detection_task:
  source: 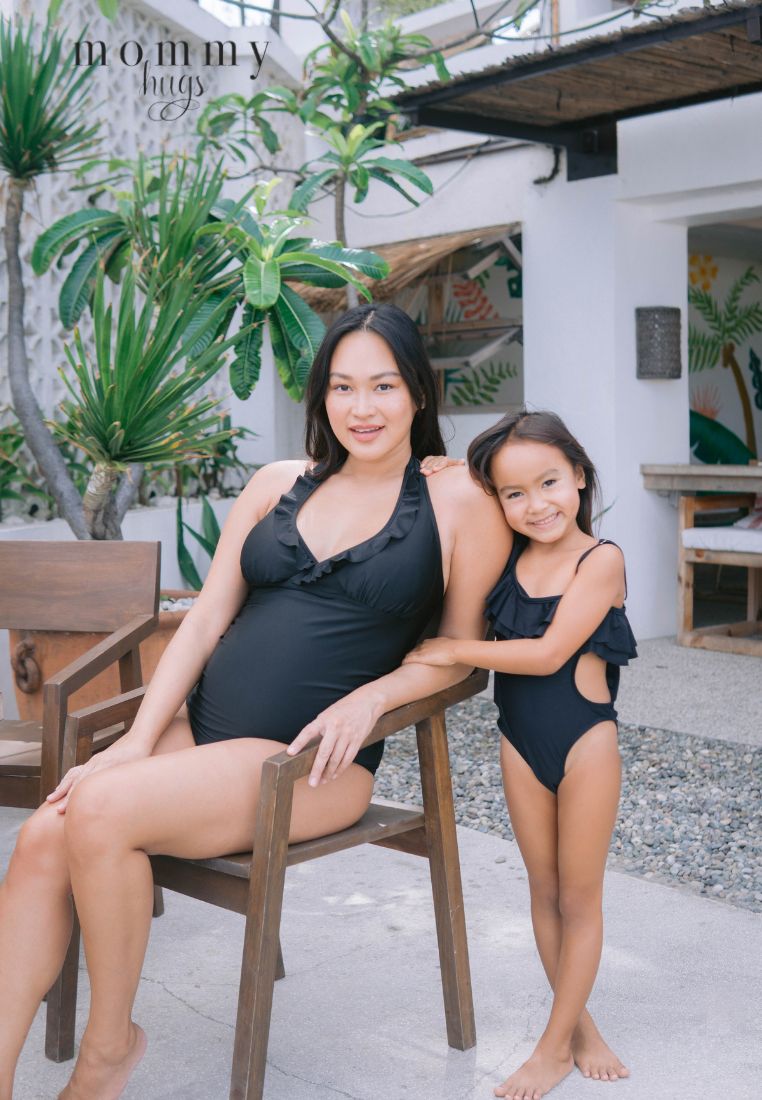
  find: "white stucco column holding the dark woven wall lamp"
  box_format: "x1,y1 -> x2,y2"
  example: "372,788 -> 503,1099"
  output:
523,176 -> 689,638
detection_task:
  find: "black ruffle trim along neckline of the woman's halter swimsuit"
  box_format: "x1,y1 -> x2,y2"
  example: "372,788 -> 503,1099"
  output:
274,458 -> 421,584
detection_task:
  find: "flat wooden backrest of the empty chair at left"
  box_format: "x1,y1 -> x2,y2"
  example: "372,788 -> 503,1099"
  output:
0,539 -> 162,631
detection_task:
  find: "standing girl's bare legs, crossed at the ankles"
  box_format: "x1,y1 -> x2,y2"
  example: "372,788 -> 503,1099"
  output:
495,725 -> 628,1100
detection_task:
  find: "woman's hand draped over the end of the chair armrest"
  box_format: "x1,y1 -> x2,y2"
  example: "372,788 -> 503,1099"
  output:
286,693 -> 383,787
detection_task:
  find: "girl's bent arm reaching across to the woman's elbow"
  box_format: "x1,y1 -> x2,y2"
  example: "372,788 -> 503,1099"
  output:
404,545 -> 625,677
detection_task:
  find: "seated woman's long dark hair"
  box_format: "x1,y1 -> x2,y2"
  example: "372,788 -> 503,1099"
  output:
305,303 -> 445,480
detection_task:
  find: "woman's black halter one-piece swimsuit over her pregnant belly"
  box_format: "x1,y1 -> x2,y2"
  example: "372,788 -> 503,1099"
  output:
188,459 -> 444,773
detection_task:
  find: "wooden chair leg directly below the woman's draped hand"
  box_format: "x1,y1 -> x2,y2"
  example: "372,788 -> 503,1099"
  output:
230,761 -> 294,1100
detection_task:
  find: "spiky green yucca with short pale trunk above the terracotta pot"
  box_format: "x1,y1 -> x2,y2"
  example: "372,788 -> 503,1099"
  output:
54,265 -> 247,539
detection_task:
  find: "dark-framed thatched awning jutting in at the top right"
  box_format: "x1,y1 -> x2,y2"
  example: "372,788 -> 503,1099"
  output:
395,0 -> 762,171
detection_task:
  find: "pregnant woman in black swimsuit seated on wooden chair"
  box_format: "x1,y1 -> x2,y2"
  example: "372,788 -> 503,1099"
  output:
0,306 -> 510,1100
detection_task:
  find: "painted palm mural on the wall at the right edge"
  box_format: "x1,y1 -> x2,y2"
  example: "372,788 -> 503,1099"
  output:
688,254 -> 762,464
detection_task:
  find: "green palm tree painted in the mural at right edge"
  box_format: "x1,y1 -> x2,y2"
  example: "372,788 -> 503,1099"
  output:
688,267 -> 762,455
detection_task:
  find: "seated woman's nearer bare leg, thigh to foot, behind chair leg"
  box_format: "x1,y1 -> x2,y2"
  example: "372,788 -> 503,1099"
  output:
62,721 -> 373,1100
